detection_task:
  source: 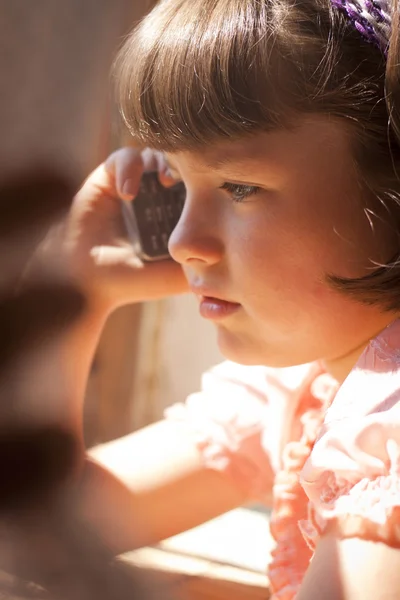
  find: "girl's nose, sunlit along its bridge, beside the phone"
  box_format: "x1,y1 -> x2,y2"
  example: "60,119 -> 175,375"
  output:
168,195 -> 224,266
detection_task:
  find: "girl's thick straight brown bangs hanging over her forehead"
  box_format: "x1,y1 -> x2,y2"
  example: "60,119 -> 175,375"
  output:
115,0 -> 298,151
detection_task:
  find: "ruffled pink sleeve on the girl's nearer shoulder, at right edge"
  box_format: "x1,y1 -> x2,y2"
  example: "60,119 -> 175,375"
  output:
300,321 -> 400,547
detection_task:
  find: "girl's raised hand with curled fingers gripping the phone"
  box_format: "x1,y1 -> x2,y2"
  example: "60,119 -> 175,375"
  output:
64,148 -> 187,310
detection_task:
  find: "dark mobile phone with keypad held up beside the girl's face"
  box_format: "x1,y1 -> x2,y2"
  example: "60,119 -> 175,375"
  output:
122,173 -> 186,261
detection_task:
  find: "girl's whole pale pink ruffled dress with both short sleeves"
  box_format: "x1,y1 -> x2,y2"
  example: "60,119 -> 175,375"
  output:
167,320 -> 400,600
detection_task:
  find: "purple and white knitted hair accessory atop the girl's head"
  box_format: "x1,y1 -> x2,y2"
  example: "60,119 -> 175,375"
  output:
331,0 -> 392,54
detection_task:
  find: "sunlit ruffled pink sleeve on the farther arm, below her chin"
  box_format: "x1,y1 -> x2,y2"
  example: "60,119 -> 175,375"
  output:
166,362 -> 318,501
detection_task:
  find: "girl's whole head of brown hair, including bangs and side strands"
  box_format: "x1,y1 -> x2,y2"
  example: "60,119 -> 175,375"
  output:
116,0 -> 400,310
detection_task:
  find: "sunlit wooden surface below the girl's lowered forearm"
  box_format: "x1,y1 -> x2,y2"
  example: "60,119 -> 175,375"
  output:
121,509 -> 272,600
